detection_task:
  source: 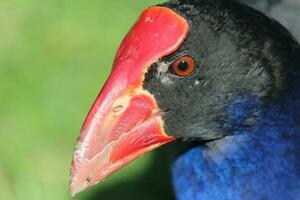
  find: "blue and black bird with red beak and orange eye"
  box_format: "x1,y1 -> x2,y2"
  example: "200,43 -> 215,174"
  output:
70,0 -> 300,200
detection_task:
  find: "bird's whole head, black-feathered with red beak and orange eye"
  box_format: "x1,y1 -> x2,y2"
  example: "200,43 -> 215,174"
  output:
70,0 -> 296,194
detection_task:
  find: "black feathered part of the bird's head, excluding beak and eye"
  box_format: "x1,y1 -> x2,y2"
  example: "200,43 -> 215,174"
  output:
144,0 -> 300,140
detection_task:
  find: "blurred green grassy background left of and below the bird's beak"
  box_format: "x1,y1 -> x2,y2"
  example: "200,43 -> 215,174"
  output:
0,0 -> 178,200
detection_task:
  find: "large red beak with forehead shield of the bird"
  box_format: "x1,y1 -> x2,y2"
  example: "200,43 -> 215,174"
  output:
70,7 -> 188,195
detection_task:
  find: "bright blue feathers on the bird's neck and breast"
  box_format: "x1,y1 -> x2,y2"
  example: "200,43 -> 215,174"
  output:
172,87 -> 300,200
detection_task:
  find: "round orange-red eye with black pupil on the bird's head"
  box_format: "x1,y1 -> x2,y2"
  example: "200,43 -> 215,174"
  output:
171,56 -> 196,76
